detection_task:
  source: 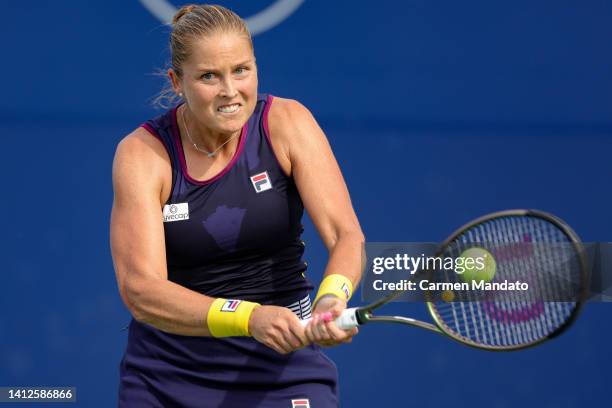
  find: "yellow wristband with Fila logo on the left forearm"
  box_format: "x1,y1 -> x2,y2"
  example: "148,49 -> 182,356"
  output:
206,298 -> 259,337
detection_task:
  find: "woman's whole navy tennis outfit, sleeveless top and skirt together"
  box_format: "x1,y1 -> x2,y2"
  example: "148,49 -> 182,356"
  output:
118,95 -> 338,408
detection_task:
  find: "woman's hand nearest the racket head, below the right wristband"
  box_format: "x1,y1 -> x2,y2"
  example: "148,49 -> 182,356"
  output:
304,296 -> 359,346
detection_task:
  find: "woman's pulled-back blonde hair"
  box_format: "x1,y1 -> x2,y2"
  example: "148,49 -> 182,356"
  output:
153,4 -> 253,108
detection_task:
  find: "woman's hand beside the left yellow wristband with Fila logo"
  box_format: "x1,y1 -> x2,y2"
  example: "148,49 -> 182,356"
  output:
249,306 -> 309,354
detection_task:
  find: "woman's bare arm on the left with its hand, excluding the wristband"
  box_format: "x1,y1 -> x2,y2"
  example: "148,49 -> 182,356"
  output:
110,128 -> 307,352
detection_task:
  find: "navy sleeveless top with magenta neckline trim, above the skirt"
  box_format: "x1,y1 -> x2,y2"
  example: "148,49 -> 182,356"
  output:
143,95 -> 313,305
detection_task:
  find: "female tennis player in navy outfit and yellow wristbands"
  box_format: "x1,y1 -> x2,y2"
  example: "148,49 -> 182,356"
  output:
111,5 -> 364,408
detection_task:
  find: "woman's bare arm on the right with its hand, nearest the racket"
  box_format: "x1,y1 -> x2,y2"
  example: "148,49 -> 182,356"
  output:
268,98 -> 364,345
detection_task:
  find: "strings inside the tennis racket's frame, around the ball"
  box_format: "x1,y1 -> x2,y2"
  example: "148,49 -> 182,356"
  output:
433,216 -> 580,347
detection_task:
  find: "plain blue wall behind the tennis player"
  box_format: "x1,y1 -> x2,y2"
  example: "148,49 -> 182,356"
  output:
0,0 -> 612,408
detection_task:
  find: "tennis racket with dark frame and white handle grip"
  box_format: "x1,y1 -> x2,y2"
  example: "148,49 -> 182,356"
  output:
304,210 -> 588,351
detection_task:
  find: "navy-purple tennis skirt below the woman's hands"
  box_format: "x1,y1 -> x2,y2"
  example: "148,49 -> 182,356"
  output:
119,312 -> 338,408
